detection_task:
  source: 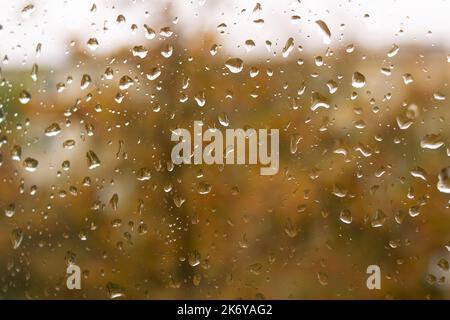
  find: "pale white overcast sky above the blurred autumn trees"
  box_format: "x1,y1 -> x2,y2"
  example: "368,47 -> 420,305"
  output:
0,0 -> 450,69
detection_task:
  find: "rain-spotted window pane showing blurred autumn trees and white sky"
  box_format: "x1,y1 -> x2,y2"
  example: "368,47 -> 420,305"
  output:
0,0 -> 450,299
